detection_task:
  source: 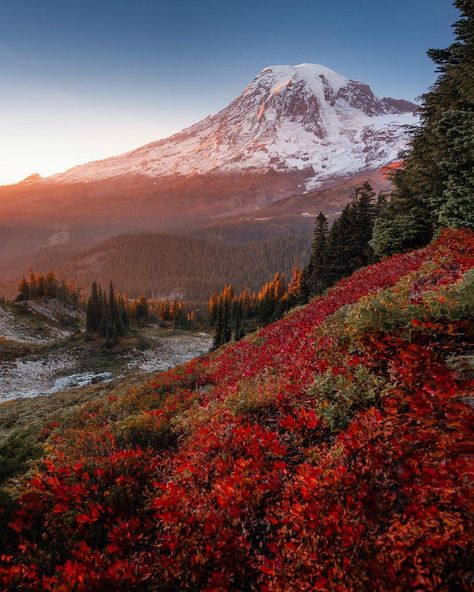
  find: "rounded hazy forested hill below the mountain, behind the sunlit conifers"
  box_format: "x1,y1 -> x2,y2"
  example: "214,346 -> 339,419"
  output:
62,234 -> 310,301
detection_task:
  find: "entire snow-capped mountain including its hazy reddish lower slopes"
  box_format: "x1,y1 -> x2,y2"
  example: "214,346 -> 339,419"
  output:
0,64 -> 417,272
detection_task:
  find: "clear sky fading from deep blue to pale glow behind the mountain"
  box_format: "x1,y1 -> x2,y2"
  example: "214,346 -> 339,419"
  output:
0,0 -> 457,183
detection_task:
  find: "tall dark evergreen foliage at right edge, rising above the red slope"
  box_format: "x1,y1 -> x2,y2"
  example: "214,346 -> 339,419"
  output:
371,0 -> 474,255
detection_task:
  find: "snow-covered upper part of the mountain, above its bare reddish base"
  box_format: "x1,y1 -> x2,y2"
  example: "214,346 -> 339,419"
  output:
48,64 -> 417,189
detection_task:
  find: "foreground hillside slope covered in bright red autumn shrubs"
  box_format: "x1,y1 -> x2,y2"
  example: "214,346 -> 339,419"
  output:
0,231 -> 474,592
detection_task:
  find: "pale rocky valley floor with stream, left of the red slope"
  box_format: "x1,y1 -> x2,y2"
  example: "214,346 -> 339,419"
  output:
0,326 -> 212,402
